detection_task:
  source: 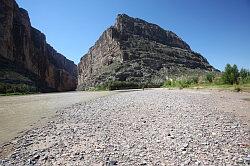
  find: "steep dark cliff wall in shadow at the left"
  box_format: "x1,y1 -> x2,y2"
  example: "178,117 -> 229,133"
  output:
0,0 -> 77,92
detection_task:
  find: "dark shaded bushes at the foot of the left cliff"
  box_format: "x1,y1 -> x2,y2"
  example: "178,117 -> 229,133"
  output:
0,83 -> 37,94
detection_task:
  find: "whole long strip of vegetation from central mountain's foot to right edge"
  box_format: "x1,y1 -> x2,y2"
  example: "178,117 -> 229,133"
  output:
85,64 -> 250,91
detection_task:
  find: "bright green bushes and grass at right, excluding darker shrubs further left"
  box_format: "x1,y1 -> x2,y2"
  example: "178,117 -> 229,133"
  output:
163,64 -> 250,91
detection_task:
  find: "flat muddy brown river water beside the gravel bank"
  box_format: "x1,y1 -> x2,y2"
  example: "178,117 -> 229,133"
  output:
0,92 -> 113,145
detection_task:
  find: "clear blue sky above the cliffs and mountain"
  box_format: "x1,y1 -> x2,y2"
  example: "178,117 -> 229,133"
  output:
17,0 -> 250,70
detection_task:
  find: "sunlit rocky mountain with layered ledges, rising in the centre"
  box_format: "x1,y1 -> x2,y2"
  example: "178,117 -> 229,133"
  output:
78,14 -> 217,89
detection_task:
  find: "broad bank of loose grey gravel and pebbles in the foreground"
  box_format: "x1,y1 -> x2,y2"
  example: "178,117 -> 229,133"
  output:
0,89 -> 250,166
